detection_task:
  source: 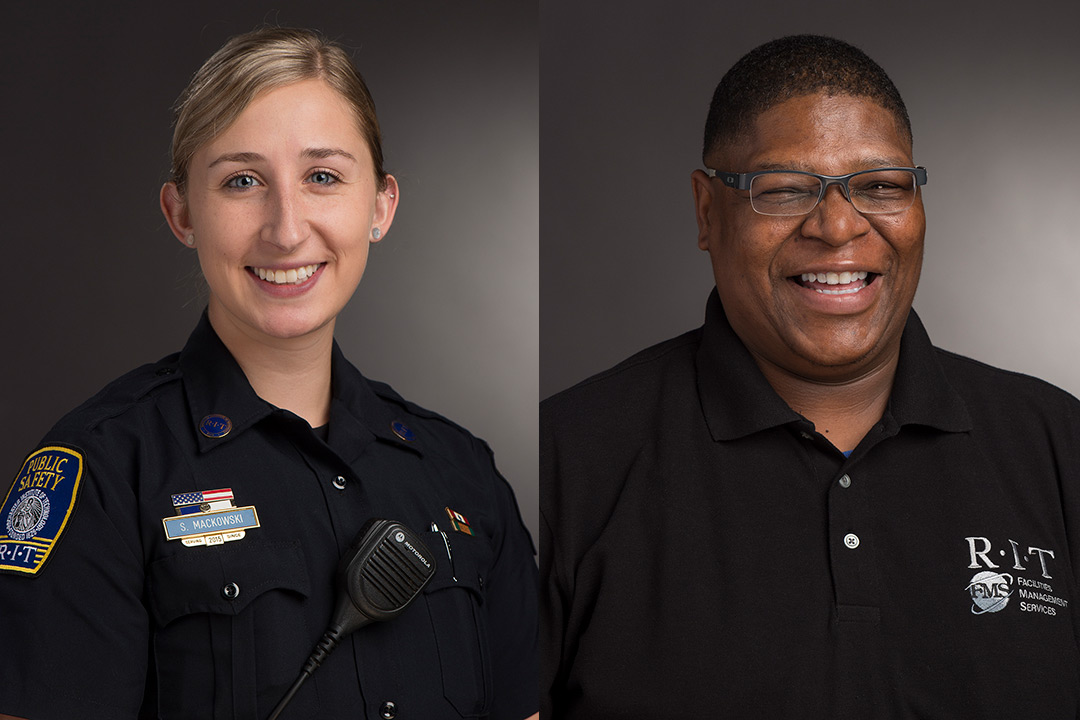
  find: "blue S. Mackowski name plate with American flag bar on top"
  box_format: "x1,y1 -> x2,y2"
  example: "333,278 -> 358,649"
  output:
161,488 -> 259,547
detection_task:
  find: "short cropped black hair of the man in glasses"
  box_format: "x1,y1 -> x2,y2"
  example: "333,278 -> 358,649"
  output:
702,35 -> 912,159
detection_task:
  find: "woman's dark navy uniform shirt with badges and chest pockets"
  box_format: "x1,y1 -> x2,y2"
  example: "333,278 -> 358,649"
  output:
0,316 -> 537,720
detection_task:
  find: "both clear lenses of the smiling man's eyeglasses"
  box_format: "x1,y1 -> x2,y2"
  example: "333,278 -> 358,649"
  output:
750,169 -> 917,215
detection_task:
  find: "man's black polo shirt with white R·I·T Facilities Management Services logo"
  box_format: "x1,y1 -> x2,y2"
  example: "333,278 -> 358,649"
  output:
540,291 -> 1080,720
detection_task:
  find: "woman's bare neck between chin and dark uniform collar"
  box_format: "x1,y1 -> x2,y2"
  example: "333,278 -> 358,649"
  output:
210,303 -> 334,427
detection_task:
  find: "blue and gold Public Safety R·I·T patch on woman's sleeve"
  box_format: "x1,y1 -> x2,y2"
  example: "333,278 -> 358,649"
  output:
0,445 -> 85,575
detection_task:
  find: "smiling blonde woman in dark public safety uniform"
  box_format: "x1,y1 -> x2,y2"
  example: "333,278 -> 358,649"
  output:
0,28 -> 538,720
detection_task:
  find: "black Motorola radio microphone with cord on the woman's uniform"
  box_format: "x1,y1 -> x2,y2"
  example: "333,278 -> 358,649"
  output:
269,519 -> 435,720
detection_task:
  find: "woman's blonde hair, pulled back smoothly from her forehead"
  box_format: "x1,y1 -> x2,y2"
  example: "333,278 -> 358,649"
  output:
170,27 -> 387,196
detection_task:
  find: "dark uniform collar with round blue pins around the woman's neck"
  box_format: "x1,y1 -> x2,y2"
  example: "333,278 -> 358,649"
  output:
179,312 -> 419,461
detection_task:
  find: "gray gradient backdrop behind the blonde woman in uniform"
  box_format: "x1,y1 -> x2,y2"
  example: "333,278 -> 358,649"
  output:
0,0 -> 539,535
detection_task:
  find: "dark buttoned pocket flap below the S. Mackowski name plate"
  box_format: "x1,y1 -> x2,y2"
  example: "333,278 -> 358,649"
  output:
149,540 -> 311,626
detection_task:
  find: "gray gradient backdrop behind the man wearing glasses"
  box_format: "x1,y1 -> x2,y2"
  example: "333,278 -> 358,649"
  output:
540,0 -> 1080,405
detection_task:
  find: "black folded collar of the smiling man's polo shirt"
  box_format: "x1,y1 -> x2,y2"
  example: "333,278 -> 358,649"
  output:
696,289 -> 971,440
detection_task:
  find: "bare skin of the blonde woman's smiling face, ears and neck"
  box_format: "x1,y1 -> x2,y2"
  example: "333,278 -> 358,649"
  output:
161,78 -> 399,426
